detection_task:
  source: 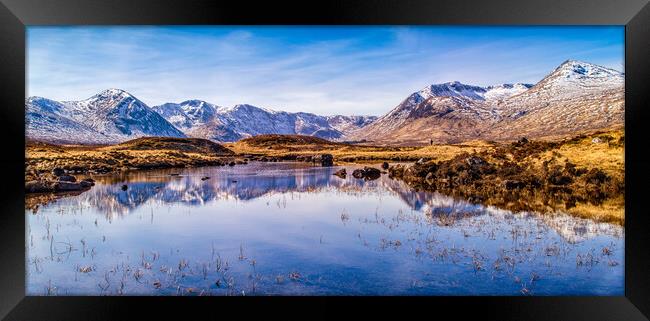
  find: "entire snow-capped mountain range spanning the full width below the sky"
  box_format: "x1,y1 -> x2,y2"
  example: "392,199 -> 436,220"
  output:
25,60 -> 624,145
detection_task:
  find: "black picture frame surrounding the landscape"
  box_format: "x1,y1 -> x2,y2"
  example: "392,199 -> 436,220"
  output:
0,0 -> 650,320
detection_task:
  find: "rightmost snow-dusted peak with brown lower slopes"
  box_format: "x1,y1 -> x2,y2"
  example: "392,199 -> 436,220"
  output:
490,60 -> 625,139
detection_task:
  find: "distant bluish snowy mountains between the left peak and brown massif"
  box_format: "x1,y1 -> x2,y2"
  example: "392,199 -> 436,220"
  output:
153,100 -> 375,142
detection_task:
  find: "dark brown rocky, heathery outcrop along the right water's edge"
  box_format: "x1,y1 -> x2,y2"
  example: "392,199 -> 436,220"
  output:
384,139 -> 625,222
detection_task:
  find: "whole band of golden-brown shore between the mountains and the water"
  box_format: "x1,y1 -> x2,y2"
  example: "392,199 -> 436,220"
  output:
25,130 -> 625,225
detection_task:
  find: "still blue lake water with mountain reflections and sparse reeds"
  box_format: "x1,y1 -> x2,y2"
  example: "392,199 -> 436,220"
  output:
25,163 -> 624,295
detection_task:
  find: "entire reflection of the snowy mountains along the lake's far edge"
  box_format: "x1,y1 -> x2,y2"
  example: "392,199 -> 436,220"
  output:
53,162 -> 622,242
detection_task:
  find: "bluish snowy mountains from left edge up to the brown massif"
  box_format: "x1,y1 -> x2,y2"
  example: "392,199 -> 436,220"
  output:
25,89 -> 377,144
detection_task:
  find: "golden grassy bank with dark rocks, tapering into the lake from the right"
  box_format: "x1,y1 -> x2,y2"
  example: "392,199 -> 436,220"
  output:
389,130 -> 625,224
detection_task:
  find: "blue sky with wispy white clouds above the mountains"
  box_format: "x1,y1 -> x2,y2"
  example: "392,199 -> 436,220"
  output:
27,26 -> 624,115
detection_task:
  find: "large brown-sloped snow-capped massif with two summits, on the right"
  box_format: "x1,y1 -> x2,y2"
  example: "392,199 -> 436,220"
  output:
351,60 -> 624,144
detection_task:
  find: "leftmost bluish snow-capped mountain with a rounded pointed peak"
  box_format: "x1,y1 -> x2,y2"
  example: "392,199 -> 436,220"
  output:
25,89 -> 185,143
